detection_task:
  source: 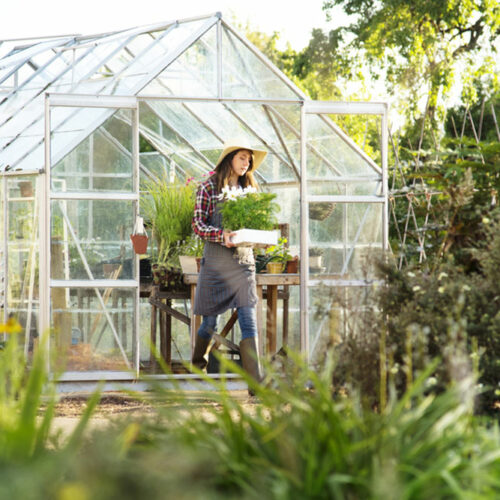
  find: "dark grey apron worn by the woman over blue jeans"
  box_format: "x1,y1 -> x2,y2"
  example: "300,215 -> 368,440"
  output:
194,204 -> 257,316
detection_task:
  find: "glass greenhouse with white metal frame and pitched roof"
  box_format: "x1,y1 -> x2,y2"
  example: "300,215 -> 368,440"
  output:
0,13 -> 388,380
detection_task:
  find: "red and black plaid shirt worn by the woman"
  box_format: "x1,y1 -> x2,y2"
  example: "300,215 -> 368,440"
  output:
192,177 -> 224,243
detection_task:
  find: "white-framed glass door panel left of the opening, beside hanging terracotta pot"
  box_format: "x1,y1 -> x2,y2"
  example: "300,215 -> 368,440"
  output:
40,94 -> 139,381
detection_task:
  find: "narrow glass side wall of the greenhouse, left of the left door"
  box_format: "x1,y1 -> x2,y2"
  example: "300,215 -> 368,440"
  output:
5,176 -> 39,346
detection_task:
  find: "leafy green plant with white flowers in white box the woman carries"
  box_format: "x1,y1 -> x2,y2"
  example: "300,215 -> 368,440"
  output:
221,186 -> 280,247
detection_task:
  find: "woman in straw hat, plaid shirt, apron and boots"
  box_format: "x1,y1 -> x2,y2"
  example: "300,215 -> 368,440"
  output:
192,140 -> 267,388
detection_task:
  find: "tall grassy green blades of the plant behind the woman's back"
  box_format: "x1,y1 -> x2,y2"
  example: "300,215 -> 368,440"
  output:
141,179 -> 196,266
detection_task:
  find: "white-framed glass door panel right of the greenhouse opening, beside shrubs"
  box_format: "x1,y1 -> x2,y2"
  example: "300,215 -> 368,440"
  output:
300,101 -> 388,361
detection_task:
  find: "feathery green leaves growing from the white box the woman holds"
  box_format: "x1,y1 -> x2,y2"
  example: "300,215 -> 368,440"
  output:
221,192 -> 280,231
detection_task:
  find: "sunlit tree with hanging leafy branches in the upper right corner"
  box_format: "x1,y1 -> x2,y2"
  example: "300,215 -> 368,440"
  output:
323,0 -> 500,129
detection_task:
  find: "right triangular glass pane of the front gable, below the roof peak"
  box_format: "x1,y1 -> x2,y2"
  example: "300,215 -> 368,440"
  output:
222,29 -> 299,100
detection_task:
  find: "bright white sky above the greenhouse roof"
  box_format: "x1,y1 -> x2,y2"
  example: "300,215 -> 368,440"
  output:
0,0 -> 341,50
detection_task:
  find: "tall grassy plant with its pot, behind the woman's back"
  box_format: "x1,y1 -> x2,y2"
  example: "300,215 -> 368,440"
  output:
141,179 -> 196,289
